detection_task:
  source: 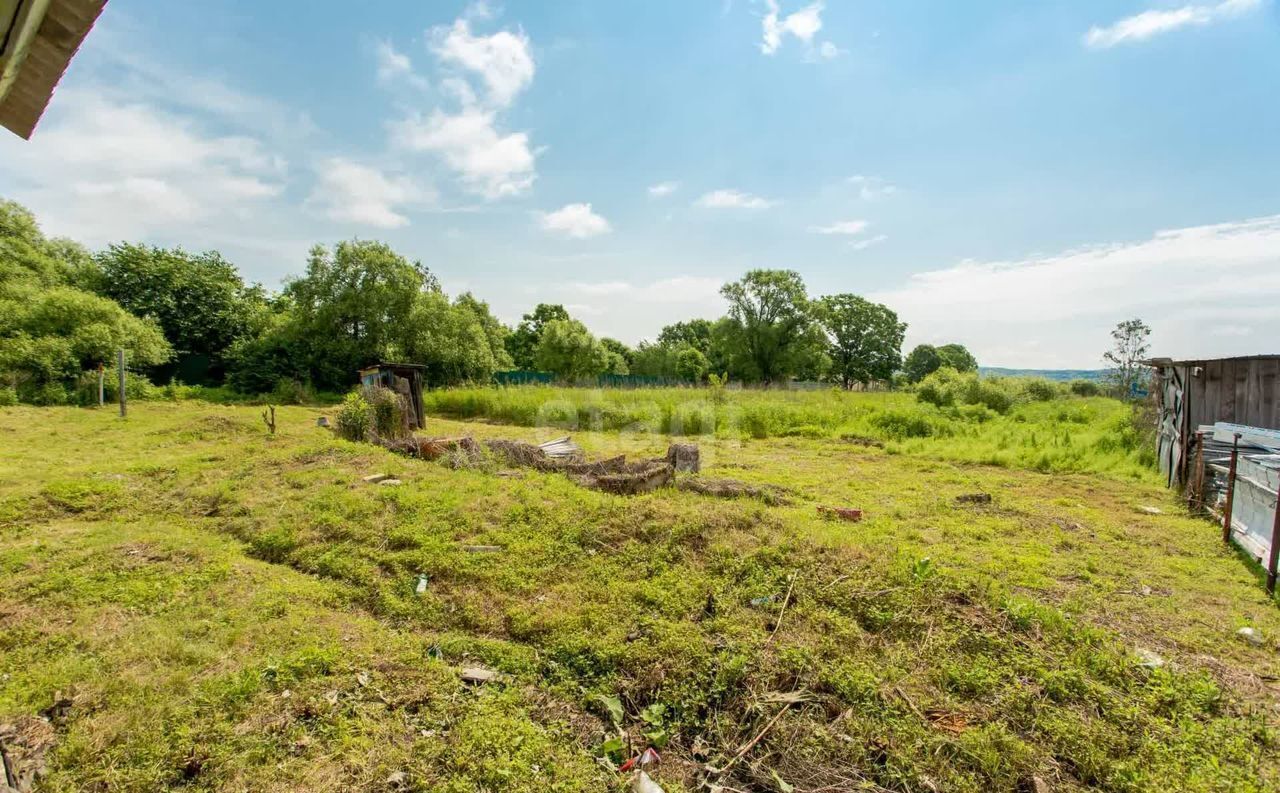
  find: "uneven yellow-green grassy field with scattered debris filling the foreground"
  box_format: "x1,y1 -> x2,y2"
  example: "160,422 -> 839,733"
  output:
0,391 -> 1280,793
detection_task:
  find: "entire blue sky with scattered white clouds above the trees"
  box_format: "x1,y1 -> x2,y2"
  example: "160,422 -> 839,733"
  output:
0,0 -> 1280,367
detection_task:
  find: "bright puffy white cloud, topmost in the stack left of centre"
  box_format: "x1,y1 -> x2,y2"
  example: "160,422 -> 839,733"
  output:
431,19 -> 534,107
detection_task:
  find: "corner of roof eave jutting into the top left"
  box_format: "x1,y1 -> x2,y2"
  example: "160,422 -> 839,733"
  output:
0,0 -> 106,138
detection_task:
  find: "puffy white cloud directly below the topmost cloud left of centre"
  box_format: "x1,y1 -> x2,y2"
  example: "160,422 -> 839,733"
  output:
390,107 -> 536,198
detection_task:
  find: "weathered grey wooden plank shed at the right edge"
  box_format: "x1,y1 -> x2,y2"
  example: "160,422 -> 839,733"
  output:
1146,356 -> 1280,486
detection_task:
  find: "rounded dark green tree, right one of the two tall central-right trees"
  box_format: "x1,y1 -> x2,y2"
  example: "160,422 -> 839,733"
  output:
817,294 -> 906,389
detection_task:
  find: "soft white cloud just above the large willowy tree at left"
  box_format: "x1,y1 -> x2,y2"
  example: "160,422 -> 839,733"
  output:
307,157 -> 433,229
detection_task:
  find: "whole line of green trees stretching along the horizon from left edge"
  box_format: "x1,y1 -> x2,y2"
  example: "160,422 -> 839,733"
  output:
0,201 -> 978,403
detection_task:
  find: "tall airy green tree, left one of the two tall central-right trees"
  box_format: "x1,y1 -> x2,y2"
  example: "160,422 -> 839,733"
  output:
713,270 -> 822,385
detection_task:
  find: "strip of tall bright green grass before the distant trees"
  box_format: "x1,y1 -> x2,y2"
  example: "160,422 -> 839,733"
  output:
425,385 -> 1153,478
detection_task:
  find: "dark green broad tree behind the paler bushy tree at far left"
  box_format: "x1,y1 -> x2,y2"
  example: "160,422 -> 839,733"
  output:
93,243 -> 266,380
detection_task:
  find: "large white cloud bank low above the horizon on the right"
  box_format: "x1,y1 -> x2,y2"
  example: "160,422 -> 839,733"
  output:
872,215 -> 1280,367
